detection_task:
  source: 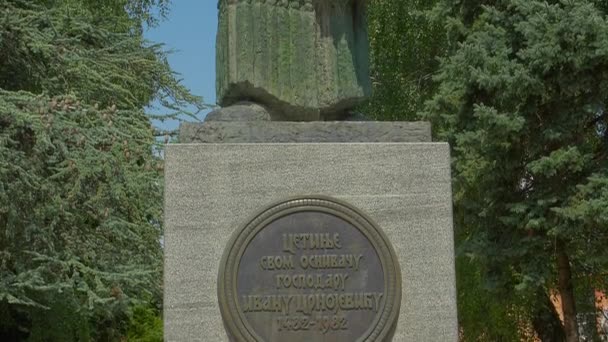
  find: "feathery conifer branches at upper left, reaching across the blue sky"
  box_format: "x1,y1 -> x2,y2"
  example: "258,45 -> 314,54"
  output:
0,0 -> 204,119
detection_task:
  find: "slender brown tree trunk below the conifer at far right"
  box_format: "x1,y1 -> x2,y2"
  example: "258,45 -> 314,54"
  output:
557,240 -> 579,342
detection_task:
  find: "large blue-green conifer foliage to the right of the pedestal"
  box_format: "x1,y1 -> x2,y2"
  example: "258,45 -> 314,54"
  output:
425,0 -> 608,340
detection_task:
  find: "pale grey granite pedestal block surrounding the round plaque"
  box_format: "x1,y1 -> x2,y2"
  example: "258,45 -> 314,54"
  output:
164,143 -> 458,342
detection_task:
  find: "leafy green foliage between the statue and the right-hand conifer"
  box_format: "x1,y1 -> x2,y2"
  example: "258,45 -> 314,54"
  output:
361,0 -> 446,120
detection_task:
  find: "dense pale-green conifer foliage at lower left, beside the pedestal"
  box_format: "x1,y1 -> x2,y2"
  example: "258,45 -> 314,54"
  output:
0,91 -> 162,340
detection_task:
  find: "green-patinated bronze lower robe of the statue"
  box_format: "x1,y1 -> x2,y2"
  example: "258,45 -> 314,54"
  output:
216,0 -> 371,120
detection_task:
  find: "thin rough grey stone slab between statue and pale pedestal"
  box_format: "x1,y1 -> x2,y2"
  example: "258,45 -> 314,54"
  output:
179,121 -> 431,143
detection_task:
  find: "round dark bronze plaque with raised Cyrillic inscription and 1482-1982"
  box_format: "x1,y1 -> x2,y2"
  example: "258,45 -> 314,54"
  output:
218,197 -> 401,342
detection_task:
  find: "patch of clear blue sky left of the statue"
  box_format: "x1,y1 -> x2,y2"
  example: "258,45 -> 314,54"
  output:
146,0 -> 217,124
